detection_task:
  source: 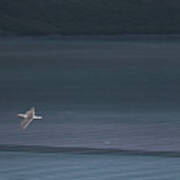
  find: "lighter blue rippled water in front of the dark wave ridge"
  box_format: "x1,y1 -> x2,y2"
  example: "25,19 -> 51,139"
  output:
0,152 -> 180,180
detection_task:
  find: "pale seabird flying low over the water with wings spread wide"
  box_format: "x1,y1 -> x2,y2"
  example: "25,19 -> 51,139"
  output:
17,107 -> 42,129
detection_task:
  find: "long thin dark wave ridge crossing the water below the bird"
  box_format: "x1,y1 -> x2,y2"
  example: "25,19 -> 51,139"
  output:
0,144 -> 180,157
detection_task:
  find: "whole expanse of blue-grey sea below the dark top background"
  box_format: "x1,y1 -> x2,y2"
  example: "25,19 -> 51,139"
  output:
0,38 -> 180,180
